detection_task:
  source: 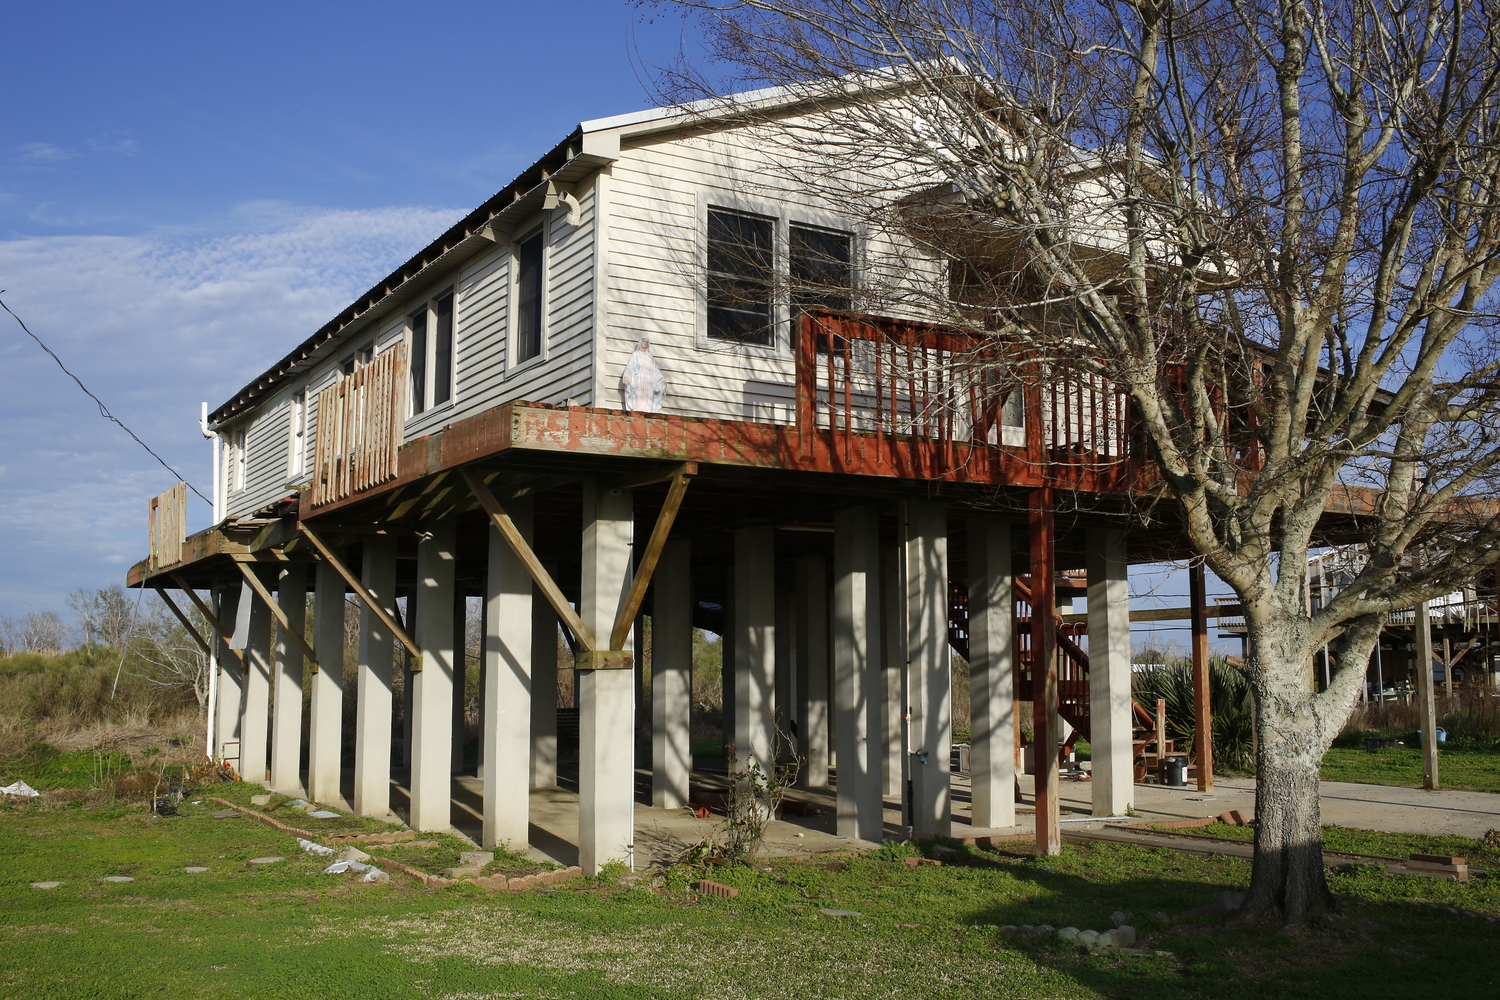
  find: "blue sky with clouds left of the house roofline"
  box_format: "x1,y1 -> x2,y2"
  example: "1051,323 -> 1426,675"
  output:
0,0 -> 1236,636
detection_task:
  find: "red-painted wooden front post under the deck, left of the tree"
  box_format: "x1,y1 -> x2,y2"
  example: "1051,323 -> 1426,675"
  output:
1031,486 -> 1062,855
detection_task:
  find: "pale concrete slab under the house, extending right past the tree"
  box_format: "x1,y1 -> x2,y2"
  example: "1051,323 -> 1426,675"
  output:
348,771 -> 1500,867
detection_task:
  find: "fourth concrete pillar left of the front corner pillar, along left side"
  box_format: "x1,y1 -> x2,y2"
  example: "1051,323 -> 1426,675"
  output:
308,553 -> 345,804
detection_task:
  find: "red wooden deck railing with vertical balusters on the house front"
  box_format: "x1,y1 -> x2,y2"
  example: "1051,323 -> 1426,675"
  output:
797,313 -> 1145,492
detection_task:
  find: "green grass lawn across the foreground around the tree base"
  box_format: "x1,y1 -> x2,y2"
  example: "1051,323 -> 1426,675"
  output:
0,786 -> 1500,1000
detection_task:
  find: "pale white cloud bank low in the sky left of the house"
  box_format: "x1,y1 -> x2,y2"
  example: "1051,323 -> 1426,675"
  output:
0,202 -> 459,616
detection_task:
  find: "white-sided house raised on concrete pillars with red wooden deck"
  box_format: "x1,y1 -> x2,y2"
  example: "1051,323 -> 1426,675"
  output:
129,83 -> 1362,871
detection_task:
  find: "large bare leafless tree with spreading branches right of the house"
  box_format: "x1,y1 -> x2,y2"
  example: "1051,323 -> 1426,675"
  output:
662,0 -> 1500,924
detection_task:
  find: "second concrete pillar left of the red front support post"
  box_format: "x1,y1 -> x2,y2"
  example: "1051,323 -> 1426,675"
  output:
902,501 -> 953,837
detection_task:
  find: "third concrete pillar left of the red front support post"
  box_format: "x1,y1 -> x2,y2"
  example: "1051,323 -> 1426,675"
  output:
833,504 -> 885,843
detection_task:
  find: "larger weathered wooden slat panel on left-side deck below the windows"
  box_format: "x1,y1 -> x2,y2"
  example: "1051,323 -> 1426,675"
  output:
311,345 -> 407,507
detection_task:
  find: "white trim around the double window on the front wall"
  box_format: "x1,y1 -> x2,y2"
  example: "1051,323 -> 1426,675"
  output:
693,189 -> 866,360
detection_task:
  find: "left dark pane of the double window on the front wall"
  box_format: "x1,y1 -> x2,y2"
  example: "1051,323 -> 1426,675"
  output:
708,208 -> 776,345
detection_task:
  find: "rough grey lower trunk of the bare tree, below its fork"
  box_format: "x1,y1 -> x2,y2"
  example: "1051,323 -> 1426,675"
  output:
1244,664 -> 1335,927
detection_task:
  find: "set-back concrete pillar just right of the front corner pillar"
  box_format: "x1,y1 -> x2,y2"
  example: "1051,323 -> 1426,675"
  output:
651,540 -> 693,810
